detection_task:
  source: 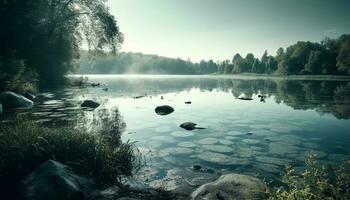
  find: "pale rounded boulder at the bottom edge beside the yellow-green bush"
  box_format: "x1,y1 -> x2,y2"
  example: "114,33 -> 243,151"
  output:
191,174 -> 268,200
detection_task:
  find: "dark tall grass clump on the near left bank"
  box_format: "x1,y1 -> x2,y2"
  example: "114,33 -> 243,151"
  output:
0,111 -> 140,184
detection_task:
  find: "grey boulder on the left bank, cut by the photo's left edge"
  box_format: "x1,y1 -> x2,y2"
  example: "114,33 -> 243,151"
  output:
0,91 -> 33,109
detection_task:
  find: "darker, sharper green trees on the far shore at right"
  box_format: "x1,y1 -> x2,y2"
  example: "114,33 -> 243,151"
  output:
218,34 -> 350,75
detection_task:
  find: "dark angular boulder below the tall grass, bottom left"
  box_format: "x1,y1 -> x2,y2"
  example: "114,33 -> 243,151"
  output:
23,160 -> 93,200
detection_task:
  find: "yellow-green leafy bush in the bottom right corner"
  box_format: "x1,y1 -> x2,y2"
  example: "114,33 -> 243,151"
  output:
269,153 -> 350,200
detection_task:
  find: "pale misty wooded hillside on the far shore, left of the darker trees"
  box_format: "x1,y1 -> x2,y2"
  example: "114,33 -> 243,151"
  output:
78,52 -> 218,74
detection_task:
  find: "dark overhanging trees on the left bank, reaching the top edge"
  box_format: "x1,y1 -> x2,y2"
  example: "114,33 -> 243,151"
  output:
0,0 -> 123,91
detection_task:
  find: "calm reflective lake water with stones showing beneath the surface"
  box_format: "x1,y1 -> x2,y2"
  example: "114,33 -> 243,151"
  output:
3,75 -> 350,190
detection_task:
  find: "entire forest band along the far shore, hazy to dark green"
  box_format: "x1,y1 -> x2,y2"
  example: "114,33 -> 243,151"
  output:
78,34 -> 350,75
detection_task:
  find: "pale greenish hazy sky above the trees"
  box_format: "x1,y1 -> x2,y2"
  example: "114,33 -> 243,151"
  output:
108,0 -> 350,61
